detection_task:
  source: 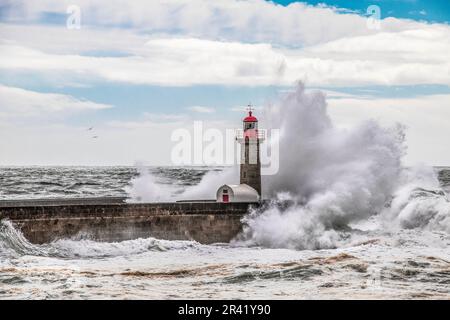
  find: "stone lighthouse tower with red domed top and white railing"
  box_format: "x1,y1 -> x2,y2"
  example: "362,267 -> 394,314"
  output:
236,106 -> 264,196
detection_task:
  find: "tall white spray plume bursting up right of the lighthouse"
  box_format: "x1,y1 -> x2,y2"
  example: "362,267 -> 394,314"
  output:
239,84 -> 405,249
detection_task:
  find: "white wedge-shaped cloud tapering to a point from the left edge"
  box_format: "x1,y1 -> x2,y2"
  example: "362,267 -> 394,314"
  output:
0,85 -> 112,118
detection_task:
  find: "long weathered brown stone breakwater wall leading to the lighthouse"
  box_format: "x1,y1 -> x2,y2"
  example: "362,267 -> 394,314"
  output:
0,198 -> 258,244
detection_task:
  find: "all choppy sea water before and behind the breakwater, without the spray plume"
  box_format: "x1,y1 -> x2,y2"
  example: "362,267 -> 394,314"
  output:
0,167 -> 450,299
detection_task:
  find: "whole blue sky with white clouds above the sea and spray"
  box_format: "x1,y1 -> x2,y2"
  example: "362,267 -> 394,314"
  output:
0,0 -> 450,166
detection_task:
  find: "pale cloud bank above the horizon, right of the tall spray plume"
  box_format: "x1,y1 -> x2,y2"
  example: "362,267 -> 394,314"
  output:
327,94 -> 450,165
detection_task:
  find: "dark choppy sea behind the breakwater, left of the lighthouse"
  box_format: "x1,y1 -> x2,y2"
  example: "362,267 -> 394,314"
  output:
0,167 -> 214,200
